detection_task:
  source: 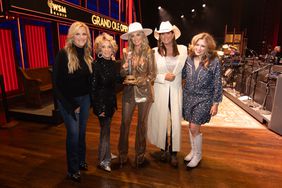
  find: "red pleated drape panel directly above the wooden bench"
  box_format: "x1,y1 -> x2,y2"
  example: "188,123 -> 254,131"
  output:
25,25 -> 49,68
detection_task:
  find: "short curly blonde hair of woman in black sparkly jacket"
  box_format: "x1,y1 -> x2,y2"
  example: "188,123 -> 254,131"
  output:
94,33 -> 118,54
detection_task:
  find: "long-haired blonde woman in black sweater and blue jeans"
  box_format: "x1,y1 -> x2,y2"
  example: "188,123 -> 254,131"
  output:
53,22 -> 93,182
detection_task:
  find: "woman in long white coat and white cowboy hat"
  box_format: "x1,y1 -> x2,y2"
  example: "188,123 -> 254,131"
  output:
148,21 -> 187,167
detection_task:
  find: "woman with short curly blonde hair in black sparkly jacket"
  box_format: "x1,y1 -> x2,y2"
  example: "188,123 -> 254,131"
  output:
91,33 -> 118,172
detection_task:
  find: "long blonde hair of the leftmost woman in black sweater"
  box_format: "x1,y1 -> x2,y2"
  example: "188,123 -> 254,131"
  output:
64,22 -> 93,73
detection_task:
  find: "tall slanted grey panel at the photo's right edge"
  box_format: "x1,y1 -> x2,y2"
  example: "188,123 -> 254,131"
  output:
268,74 -> 282,135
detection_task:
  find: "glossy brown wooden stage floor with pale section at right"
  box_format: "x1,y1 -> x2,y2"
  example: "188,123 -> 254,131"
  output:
0,93 -> 282,188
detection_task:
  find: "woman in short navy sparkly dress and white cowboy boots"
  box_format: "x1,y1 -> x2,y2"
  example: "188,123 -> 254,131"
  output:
182,33 -> 222,168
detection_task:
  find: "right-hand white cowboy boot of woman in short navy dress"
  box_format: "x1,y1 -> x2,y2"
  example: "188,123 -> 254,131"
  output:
187,133 -> 202,168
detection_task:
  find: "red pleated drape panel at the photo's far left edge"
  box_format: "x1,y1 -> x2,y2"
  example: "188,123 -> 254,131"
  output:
0,28 -> 19,92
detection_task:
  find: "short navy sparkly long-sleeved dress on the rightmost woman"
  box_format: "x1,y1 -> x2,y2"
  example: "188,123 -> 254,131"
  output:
182,57 -> 222,125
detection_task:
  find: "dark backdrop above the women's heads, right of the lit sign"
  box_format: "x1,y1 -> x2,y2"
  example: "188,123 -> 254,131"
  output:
140,0 -> 282,54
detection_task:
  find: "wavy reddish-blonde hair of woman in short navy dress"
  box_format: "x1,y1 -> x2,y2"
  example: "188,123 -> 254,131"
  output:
188,33 -> 217,68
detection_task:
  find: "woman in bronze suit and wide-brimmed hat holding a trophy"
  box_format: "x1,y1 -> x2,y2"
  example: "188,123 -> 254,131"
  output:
118,22 -> 156,168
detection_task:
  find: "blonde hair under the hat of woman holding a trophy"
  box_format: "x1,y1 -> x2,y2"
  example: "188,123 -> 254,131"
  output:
127,31 -> 151,58
